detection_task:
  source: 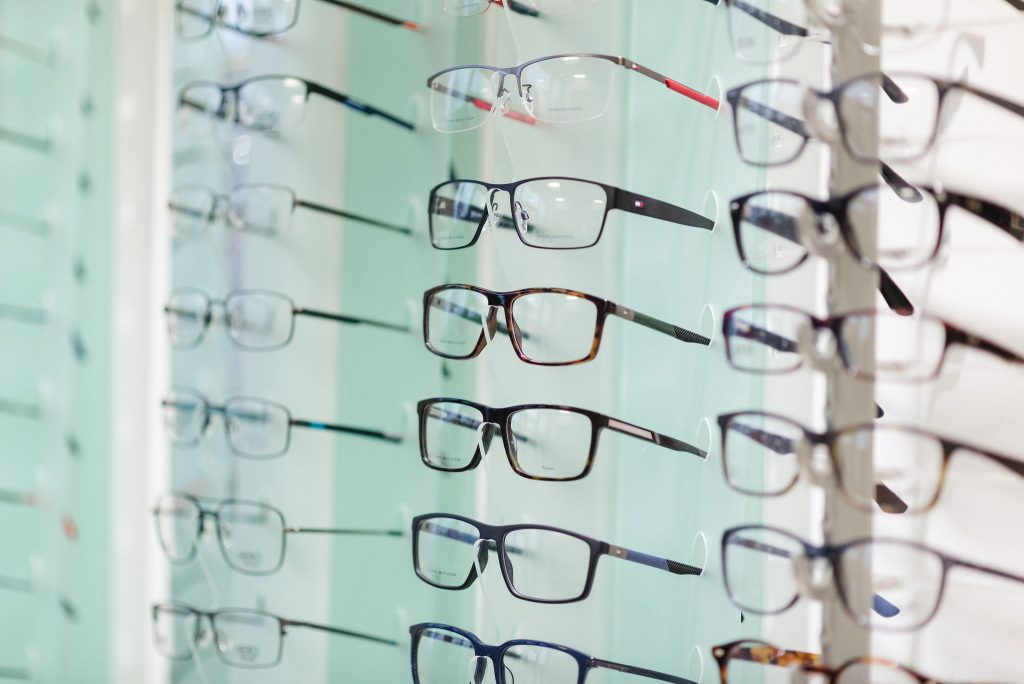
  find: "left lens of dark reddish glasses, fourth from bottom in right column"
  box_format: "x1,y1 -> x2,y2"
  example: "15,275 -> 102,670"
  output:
725,306 -> 811,373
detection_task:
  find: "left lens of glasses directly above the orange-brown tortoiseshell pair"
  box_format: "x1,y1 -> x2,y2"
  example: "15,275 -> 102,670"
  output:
722,527 -> 804,614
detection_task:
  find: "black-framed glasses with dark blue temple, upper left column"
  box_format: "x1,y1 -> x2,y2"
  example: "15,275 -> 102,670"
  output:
178,76 -> 416,137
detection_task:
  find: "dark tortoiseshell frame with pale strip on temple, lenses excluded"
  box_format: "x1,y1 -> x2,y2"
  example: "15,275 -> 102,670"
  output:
416,396 -> 708,482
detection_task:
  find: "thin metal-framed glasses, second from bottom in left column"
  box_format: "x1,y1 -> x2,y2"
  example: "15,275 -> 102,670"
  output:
153,491 -> 401,574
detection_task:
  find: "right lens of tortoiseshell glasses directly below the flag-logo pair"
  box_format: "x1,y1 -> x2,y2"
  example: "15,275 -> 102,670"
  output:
512,292 -> 597,365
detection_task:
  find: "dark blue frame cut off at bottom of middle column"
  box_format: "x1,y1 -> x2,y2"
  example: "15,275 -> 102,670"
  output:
409,623 -> 696,684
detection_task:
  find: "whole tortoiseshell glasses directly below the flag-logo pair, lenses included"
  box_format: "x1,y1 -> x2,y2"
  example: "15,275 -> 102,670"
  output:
423,285 -> 711,366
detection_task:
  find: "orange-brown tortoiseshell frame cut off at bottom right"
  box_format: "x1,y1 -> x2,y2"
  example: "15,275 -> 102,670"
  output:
712,639 -> 941,684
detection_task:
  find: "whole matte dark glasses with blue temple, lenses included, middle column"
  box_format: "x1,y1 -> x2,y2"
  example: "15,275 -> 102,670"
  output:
413,513 -> 702,603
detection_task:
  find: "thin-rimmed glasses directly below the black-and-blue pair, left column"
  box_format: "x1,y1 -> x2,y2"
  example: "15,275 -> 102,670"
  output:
168,183 -> 413,240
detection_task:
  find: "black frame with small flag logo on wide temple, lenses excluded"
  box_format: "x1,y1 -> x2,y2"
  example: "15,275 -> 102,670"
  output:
427,176 -> 715,251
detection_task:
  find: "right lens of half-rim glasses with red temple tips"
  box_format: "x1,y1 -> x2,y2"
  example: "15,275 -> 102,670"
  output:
519,56 -> 618,122
